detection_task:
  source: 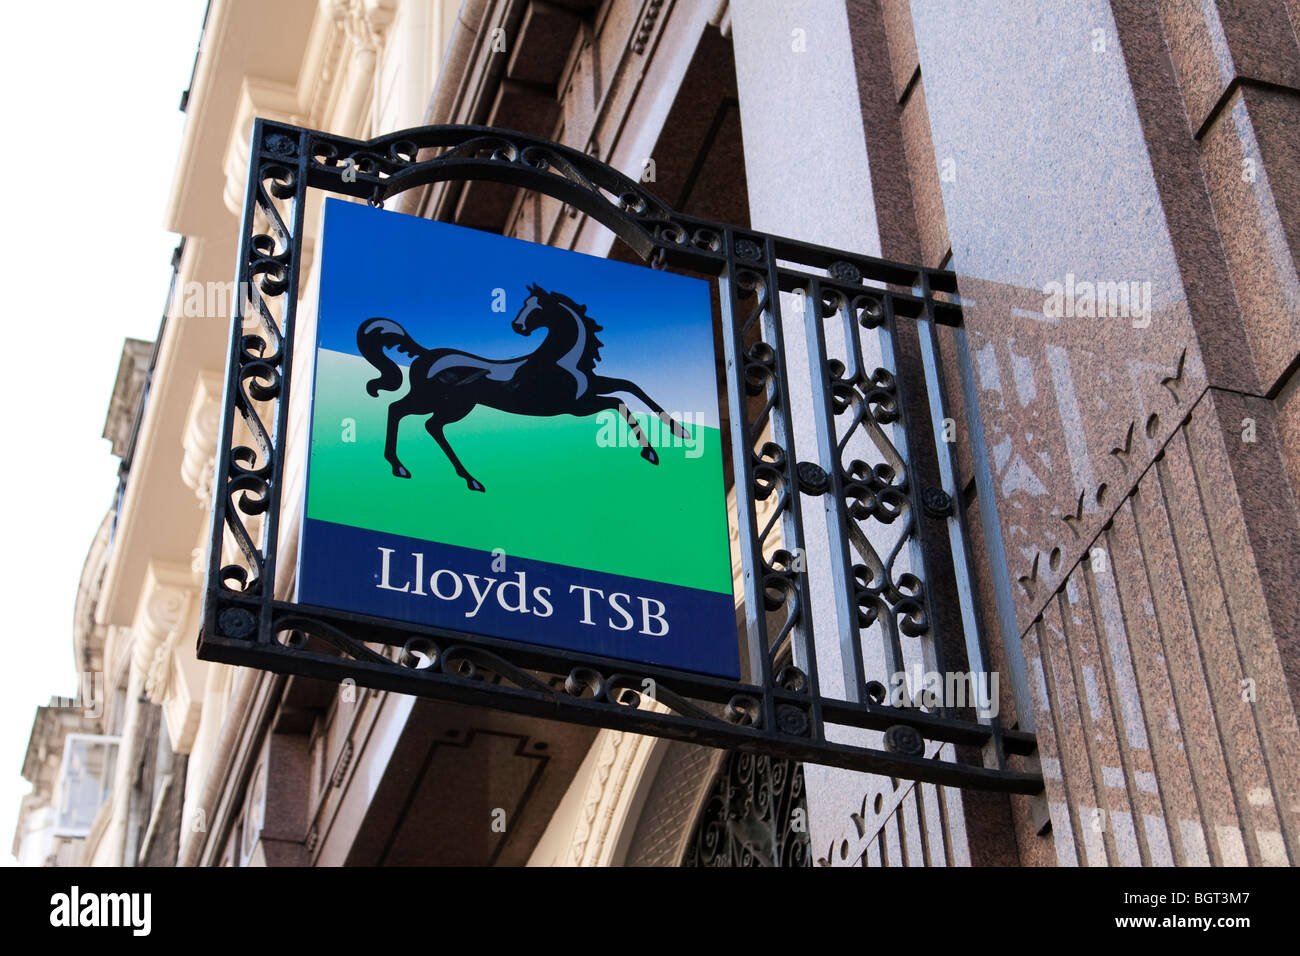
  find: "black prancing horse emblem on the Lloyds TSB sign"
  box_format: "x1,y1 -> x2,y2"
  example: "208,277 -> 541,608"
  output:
356,285 -> 690,492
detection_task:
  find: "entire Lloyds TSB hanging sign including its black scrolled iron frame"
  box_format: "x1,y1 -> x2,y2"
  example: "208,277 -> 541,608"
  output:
198,120 -> 1043,793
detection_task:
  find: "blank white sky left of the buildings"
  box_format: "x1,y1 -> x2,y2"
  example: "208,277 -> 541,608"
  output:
0,0 -> 209,865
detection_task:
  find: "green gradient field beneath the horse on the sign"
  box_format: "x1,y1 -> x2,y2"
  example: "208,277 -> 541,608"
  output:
307,349 -> 732,594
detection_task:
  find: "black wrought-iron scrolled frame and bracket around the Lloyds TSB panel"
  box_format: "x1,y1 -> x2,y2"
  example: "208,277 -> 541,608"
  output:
199,120 -> 1043,793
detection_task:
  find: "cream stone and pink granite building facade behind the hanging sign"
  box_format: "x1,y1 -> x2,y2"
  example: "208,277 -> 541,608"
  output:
17,0 -> 1300,866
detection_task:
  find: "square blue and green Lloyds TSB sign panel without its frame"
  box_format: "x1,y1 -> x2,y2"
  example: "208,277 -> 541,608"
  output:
298,199 -> 740,679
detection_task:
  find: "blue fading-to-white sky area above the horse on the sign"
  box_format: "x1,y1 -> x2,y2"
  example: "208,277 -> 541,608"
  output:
319,199 -> 719,428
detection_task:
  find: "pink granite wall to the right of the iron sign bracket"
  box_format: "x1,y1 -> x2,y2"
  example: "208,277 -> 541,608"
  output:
849,0 -> 1300,865
